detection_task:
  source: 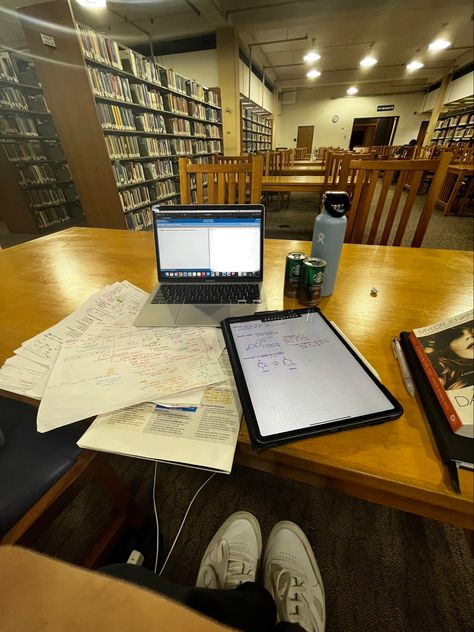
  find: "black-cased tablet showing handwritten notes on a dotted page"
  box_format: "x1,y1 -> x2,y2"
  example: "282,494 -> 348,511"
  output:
221,308 -> 403,449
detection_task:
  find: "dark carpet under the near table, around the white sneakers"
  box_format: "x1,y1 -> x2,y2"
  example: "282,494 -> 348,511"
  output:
31,456 -> 474,632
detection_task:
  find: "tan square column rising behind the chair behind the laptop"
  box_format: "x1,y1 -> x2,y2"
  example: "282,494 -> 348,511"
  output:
216,28 -> 241,156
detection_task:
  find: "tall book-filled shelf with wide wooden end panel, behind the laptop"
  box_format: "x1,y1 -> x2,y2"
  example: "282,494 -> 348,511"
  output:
19,1 -> 222,230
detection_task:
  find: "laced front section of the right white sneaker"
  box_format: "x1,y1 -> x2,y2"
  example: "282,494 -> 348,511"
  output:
273,569 -> 320,632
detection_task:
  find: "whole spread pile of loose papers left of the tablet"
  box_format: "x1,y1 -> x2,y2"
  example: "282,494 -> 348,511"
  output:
0,281 -> 242,472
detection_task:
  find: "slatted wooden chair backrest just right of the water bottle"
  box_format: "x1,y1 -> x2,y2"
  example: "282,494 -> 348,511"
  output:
345,152 -> 451,247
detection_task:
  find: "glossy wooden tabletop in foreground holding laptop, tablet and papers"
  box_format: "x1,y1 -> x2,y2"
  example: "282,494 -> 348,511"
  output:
0,228 -> 473,529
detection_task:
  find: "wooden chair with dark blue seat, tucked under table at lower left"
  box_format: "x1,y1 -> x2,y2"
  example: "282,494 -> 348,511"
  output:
0,397 -> 142,567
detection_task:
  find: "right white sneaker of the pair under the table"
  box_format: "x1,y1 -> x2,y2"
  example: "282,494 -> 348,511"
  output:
263,521 -> 326,632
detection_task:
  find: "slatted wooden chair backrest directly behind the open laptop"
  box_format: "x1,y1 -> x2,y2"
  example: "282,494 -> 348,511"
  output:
179,156 -> 263,204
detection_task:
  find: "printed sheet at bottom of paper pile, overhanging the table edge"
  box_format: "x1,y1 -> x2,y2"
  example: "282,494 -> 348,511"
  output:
78,352 -> 242,473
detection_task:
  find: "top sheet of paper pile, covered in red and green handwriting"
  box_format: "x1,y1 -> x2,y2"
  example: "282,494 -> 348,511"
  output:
37,324 -> 225,432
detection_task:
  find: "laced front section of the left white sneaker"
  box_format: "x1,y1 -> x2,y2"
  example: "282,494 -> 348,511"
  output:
204,540 -> 255,588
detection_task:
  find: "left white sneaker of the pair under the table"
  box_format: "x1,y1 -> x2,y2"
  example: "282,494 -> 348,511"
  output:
196,511 -> 262,588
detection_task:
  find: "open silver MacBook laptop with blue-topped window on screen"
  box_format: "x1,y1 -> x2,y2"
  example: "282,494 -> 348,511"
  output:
134,204 -> 266,327
